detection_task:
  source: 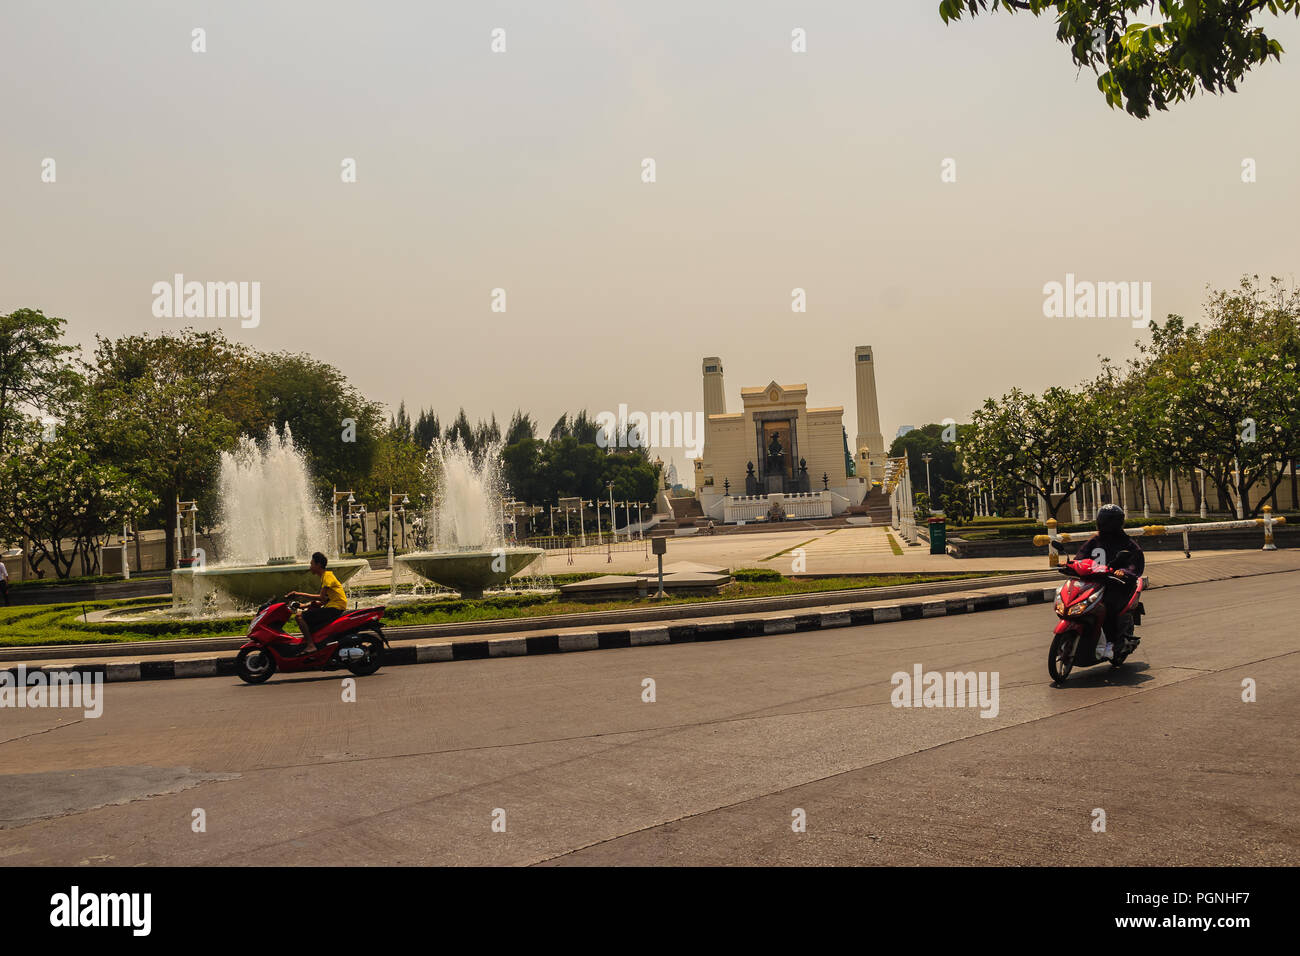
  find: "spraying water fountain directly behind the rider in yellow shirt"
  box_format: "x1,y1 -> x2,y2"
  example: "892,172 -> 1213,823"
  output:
172,425 -> 369,611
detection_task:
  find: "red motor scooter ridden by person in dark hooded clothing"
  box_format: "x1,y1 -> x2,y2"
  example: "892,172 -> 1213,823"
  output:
1048,551 -> 1147,684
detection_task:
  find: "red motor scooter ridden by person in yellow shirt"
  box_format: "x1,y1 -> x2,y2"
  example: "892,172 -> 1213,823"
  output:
235,601 -> 389,684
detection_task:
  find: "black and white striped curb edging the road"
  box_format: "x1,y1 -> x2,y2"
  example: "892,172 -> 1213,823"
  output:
7,587 -> 1057,683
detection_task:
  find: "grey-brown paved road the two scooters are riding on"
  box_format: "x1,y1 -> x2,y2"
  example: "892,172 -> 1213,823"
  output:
0,572 -> 1300,865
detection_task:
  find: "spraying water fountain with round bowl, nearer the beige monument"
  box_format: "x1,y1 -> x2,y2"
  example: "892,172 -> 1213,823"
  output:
397,441 -> 542,598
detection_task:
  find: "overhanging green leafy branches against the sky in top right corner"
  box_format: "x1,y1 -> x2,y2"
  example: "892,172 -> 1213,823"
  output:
939,0 -> 1300,120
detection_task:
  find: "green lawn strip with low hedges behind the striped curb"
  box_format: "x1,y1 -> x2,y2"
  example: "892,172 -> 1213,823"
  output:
0,571 -> 1010,646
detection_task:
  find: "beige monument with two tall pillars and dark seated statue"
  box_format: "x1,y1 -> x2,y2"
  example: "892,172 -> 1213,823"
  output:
696,346 -> 884,522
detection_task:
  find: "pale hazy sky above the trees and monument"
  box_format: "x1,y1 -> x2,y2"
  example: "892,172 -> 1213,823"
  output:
0,0 -> 1300,475
